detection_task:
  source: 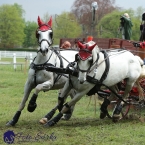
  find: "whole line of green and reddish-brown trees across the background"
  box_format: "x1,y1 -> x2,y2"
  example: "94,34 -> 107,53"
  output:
0,0 -> 145,48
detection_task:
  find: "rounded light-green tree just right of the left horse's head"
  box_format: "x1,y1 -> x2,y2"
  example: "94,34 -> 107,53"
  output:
53,12 -> 81,44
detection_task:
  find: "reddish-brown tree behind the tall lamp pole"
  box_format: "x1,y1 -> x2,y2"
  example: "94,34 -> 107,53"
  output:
71,0 -> 115,35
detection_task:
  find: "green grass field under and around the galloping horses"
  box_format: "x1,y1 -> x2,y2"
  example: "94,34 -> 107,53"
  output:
0,60 -> 145,145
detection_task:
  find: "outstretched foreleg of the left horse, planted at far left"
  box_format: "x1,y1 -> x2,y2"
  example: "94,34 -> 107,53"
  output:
6,80 -> 34,126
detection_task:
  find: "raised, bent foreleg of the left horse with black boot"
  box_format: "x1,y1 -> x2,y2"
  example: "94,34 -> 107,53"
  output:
27,81 -> 53,112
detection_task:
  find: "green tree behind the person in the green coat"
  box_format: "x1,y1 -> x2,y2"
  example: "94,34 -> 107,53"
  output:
96,9 -> 140,41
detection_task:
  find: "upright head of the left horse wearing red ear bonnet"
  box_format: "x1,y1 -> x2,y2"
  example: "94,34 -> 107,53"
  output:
36,16 -> 53,55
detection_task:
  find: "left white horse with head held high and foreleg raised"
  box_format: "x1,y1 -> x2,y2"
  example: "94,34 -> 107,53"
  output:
6,16 -> 77,126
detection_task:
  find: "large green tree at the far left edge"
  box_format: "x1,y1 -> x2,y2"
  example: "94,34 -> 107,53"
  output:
0,4 -> 25,48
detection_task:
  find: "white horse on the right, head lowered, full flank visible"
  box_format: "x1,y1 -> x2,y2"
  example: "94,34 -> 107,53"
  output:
45,42 -> 143,127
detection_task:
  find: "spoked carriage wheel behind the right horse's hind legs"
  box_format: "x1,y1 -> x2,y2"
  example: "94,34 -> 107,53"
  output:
107,100 -> 130,120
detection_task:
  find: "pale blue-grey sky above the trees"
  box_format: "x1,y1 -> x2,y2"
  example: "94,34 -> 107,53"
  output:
0,0 -> 145,21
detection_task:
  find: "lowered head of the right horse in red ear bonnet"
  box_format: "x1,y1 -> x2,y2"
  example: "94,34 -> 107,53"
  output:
76,42 -> 97,84
